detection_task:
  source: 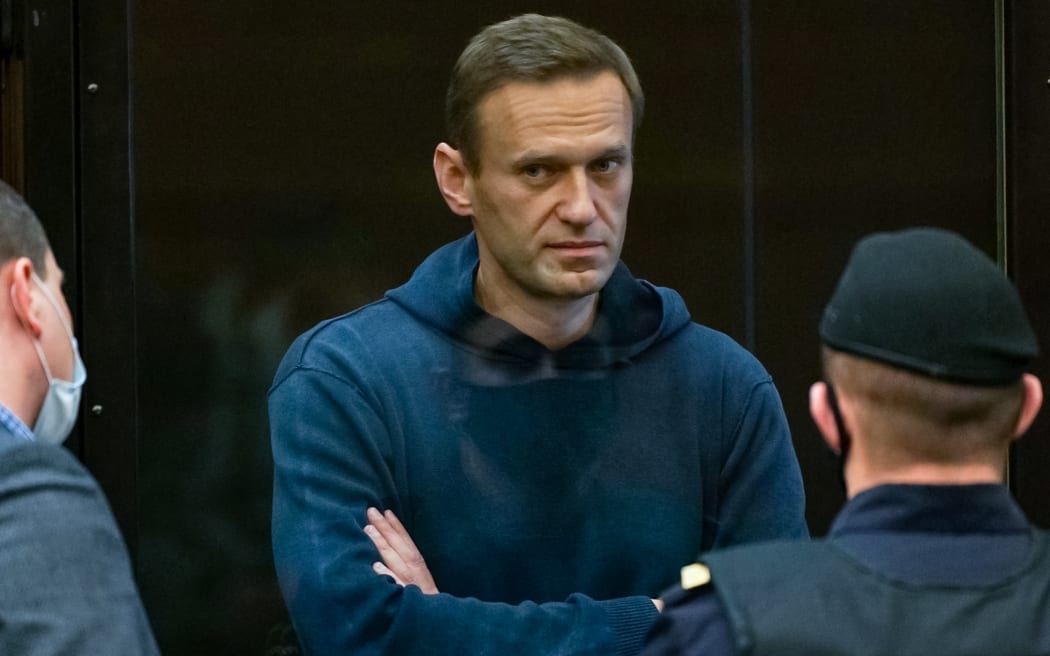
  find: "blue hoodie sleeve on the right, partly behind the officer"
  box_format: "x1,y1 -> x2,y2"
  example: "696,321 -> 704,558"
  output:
712,376 -> 810,549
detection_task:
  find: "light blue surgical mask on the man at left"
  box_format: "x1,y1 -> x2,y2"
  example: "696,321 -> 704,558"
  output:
33,273 -> 87,444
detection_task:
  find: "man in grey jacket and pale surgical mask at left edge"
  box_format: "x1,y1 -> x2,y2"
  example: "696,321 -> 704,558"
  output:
0,177 -> 158,655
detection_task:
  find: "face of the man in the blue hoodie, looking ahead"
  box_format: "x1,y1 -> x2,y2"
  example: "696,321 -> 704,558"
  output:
466,72 -> 633,302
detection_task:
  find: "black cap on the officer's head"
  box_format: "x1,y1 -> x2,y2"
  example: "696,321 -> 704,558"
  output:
820,228 -> 1038,385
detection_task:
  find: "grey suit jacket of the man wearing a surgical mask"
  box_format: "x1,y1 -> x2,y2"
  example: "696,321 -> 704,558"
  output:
0,426 -> 159,656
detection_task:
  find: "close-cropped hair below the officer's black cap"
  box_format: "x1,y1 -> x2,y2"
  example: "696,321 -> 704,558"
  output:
821,346 -> 1024,463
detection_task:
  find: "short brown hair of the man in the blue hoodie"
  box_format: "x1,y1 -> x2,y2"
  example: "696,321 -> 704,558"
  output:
445,14 -> 645,173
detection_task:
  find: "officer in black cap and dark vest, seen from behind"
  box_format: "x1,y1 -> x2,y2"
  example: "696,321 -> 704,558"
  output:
645,228 -> 1050,656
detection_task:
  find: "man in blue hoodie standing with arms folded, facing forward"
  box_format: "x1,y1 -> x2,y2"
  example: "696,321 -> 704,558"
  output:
269,15 -> 806,656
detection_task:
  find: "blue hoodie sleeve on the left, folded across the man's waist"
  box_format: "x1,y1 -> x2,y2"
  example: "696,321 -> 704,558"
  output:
269,363 -> 657,656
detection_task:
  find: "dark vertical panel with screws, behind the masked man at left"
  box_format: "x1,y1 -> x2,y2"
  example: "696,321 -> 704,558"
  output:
76,0 -> 139,564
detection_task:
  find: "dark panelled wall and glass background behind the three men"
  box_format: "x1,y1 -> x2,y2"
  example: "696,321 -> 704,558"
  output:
3,0 -> 1050,655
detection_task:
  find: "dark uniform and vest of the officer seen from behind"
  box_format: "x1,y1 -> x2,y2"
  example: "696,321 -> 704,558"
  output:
644,485 -> 1050,656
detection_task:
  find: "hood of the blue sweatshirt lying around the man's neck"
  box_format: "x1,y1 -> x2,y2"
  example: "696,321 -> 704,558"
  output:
386,233 -> 690,369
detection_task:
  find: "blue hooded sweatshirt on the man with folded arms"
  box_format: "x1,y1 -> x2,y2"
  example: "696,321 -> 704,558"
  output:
269,235 -> 806,656
